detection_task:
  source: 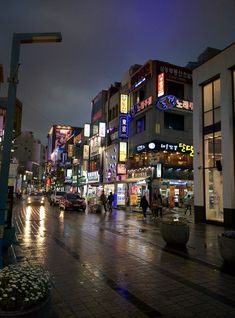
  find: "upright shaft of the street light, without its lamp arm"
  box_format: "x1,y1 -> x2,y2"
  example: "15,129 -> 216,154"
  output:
0,35 -> 20,268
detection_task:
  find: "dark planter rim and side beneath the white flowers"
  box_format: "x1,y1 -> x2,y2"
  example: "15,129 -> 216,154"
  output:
0,296 -> 51,318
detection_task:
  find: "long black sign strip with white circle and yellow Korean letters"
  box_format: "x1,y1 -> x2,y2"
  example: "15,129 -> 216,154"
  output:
136,141 -> 193,157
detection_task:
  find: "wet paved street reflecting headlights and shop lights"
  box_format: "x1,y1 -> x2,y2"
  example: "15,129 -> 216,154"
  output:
9,200 -> 235,318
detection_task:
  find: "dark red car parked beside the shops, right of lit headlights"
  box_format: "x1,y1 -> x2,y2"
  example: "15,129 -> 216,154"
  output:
59,193 -> 86,211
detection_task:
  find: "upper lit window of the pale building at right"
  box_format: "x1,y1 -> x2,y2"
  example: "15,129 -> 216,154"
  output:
203,78 -> 220,132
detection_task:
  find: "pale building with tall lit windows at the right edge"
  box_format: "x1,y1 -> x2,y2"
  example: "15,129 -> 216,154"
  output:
193,43 -> 235,226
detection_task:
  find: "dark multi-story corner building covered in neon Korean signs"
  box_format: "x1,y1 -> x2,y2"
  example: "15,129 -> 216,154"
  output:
126,60 -> 193,207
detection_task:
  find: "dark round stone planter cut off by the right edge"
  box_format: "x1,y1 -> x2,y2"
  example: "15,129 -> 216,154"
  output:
218,235 -> 235,264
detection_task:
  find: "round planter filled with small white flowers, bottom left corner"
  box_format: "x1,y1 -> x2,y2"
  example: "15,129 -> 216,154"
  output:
0,264 -> 50,317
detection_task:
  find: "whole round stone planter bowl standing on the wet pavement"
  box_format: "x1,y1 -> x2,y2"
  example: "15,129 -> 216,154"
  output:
160,221 -> 189,246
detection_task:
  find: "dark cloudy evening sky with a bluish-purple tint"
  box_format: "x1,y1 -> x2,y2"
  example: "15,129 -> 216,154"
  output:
0,0 -> 235,143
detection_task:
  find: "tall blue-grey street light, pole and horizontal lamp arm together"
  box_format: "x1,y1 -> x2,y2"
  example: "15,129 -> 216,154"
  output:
0,32 -> 62,268
